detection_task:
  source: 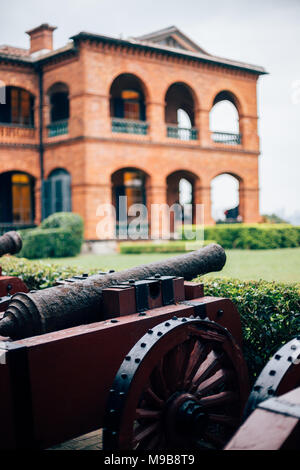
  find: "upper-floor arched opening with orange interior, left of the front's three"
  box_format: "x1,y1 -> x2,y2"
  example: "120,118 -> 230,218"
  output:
110,73 -> 148,134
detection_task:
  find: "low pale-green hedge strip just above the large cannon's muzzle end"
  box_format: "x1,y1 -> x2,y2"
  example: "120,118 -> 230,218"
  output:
119,240 -> 215,254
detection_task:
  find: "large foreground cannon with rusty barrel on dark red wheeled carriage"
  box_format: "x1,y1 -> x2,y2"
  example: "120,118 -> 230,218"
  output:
0,244 -> 300,451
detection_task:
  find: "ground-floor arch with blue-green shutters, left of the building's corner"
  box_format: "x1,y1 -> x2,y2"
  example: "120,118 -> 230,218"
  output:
43,168 -> 72,217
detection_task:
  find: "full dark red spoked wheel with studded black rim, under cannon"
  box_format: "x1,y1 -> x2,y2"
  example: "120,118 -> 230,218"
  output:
103,317 -> 249,450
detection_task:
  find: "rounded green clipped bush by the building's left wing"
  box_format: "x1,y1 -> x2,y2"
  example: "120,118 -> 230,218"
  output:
18,212 -> 83,259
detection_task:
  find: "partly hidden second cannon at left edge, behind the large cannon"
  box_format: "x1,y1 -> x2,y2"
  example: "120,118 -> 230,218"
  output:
0,231 -> 28,318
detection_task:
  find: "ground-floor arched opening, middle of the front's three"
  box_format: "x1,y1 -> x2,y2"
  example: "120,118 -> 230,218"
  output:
167,170 -> 198,233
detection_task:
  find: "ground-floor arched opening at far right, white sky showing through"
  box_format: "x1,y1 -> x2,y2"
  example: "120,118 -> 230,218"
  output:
211,173 -> 242,223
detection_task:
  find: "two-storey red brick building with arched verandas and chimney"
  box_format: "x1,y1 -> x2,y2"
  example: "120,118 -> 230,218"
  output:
0,24 -> 265,240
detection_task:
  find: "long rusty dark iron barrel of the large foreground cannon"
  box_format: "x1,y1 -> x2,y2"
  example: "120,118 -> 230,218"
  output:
0,244 -> 226,339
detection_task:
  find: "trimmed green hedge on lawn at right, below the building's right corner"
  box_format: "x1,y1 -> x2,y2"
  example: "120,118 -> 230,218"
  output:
182,224 -> 300,250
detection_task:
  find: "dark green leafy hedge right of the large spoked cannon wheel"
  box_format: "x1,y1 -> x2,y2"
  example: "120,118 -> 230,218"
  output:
202,278 -> 300,382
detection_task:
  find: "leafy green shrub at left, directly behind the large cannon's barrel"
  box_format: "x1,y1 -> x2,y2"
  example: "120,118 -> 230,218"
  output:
0,255 -> 97,290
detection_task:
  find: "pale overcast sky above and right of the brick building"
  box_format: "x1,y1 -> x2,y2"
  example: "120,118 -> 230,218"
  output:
0,0 -> 300,222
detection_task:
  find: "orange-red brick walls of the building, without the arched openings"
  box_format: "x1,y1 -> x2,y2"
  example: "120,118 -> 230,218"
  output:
0,25 -> 264,240
